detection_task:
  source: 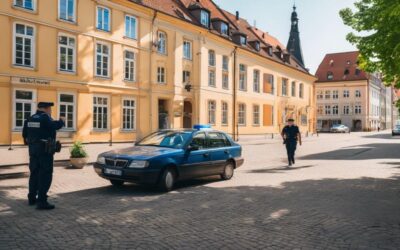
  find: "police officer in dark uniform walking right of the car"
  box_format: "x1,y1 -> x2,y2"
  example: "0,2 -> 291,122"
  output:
281,118 -> 301,167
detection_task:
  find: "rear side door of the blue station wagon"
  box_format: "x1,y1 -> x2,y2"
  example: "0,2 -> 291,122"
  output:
208,132 -> 231,175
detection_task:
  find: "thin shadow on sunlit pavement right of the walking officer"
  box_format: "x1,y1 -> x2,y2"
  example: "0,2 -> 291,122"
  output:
300,143 -> 400,160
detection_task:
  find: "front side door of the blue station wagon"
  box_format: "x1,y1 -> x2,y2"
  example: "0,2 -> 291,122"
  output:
179,132 -> 210,179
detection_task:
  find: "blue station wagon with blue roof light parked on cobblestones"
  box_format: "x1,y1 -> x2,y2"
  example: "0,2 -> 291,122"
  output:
94,126 -> 244,191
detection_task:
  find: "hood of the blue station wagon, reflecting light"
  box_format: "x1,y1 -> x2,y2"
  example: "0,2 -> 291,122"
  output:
102,146 -> 182,160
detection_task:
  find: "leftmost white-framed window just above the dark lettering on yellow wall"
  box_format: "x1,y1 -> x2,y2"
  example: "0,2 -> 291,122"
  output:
12,22 -> 36,69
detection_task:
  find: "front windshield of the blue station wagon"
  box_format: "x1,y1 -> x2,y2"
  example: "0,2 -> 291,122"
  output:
136,131 -> 192,148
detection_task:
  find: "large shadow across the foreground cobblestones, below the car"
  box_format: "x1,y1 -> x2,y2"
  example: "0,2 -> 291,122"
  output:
0,176 -> 400,249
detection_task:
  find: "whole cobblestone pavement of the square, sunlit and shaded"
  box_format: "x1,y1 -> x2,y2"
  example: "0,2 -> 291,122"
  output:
0,133 -> 400,249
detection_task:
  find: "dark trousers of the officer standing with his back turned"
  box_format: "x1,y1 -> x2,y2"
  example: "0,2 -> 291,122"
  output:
28,153 -> 53,202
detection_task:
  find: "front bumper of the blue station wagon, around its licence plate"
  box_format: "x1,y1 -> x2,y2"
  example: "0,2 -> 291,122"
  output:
93,163 -> 160,185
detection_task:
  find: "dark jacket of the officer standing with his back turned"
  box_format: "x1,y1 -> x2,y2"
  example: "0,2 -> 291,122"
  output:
22,111 -> 65,144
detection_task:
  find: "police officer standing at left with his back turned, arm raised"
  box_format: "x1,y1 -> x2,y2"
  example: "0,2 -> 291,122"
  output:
22,102 -> 65,209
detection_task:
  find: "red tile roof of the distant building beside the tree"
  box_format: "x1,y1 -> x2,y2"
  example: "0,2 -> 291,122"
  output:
315,51 -> 368,82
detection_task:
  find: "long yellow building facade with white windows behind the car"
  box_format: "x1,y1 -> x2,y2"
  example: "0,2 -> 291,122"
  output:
0,0 -> 315,145
